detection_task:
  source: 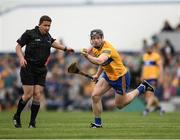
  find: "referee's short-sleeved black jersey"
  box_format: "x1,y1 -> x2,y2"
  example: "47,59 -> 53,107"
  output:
17,26 -> 55,66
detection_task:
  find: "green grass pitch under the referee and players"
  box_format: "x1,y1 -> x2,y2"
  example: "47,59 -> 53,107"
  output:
0,111 -> 180,139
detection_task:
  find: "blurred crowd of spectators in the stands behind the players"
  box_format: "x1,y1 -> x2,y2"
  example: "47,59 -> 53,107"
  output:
0,21 -> 180,111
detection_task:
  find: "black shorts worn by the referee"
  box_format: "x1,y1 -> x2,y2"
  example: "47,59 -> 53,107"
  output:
20,64 -> 47,86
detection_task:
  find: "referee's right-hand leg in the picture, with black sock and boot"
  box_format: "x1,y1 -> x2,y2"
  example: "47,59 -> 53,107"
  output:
29,85 -> 44,128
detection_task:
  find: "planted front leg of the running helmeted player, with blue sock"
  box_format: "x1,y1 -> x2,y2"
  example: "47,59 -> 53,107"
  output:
91,78 -> 111,127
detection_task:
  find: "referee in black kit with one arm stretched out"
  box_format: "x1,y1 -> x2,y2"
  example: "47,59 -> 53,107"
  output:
13,15 -> 74,128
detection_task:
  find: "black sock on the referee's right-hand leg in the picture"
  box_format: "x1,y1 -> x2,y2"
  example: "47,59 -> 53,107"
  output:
30,101 -> 40,123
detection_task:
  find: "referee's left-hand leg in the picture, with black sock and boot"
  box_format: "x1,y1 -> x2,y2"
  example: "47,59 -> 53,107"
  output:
13,85 -> 33,128
